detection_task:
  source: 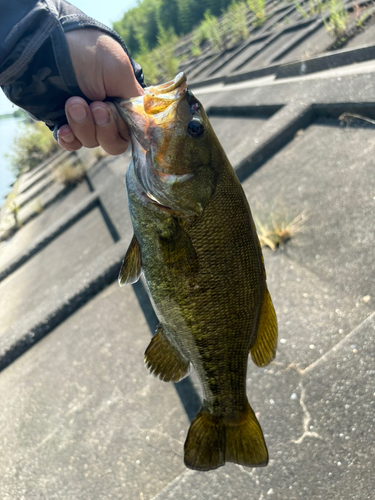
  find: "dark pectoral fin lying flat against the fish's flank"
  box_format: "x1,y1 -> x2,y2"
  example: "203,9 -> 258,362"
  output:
159,221 -> 199,274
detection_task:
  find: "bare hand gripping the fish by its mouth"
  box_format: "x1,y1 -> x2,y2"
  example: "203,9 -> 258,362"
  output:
58,29 -> 144,155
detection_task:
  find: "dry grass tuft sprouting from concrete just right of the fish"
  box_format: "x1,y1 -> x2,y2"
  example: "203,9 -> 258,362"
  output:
254,212 -> 309,251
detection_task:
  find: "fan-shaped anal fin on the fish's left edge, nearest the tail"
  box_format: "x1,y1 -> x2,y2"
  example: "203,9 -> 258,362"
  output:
144,325 -> 190,382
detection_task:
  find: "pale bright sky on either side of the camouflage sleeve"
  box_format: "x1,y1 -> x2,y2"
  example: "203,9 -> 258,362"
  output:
0,0 -> 138,115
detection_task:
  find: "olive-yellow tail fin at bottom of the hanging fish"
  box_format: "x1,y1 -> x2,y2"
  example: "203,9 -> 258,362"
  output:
184,404 -> 268,471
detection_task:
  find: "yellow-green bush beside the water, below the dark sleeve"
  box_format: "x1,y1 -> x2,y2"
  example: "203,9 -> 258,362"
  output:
9,122 -> 59,177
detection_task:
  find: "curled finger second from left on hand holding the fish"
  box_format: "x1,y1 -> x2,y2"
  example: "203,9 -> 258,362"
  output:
65,97 -> 99,148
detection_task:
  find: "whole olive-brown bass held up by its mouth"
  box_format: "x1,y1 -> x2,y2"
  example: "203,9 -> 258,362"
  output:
116,73 -> 277,471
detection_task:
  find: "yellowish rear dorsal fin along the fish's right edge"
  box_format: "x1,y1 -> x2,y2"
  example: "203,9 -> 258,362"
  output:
250,287 -> 277,366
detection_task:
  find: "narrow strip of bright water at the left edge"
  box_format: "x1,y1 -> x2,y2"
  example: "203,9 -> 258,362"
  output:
0,118 -> 20,203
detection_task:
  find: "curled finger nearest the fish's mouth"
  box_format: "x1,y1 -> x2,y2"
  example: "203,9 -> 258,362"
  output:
90,102 -> 129,155
